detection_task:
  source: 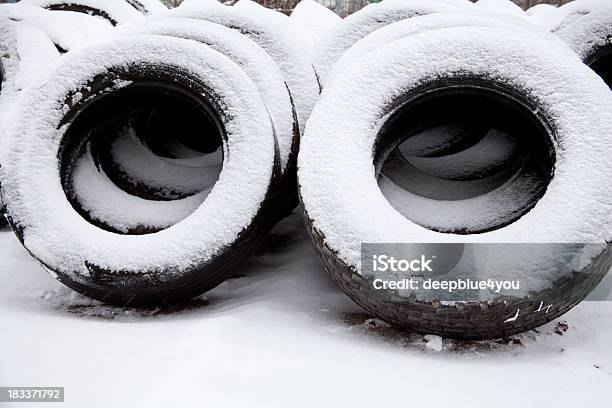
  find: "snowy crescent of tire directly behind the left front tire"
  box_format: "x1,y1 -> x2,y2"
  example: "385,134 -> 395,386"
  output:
119,18 -> 300,217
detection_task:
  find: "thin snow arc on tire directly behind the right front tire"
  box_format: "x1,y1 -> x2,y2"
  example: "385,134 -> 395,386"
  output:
328,10 -> 556,81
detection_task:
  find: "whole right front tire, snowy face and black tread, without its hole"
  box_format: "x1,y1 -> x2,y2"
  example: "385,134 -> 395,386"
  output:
298,27 -> 612,339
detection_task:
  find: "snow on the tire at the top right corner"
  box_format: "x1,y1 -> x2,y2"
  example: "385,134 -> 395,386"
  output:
556,5 -> 612,60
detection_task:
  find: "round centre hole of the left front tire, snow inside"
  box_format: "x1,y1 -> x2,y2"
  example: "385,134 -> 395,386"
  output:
61,80 -> 224,234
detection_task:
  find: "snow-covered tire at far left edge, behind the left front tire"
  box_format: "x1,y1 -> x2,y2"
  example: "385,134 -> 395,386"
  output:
0,10 -> 60,227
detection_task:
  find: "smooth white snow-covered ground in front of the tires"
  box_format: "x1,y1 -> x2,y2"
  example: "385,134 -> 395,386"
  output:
0,216 -> 612,408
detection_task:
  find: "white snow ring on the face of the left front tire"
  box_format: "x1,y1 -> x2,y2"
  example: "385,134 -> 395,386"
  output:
0,36 -> 276,279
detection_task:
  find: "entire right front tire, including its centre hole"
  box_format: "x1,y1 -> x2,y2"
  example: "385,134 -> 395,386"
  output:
298,27 -> 612,339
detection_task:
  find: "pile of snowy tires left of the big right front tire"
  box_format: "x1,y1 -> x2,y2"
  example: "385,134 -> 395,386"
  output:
0,0 -> 319,305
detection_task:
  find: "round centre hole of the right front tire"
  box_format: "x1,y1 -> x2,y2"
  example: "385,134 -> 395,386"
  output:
375,85 -> 554,234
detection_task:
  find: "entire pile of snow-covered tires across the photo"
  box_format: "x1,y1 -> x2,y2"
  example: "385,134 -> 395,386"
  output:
0,0 -> 612,338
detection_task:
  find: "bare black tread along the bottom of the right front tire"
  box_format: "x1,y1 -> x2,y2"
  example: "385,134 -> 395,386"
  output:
303,211 -> 612,340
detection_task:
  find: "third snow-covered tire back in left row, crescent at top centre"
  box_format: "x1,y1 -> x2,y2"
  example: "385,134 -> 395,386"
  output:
165,1 -> 320,131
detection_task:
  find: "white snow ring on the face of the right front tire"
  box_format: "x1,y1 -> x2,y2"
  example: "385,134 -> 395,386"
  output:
298,27 -> 612,294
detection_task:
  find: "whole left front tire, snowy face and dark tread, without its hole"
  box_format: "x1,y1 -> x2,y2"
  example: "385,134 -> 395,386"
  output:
0,36 -> 280,306
